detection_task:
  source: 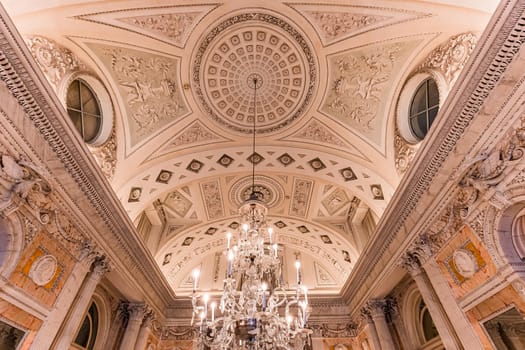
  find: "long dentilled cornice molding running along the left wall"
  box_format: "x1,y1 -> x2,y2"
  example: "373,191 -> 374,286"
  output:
0,7 -> 174,310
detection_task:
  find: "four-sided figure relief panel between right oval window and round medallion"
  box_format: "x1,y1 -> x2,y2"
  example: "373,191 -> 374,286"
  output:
321,40 -> 419,144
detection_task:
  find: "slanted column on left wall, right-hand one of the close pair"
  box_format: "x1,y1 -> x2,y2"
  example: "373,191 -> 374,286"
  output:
55,257 -> 109,349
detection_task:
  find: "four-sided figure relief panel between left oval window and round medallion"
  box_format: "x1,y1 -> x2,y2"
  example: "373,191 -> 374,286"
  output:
88,44 -> 188,145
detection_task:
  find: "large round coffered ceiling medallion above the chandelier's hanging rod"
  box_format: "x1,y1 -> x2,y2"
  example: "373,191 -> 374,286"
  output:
192,13 -> 317,134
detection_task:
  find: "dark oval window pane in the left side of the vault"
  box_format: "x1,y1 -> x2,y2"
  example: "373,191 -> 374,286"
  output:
66,79 -> 102,143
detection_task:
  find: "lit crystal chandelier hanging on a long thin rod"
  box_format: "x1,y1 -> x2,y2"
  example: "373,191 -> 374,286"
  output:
192,77 -> 312,350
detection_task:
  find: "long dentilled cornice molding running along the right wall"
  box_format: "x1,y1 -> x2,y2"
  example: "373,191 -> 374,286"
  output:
342,0 -> 525,314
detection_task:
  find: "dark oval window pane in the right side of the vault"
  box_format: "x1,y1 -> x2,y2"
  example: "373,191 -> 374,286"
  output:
409,78 -> 439,140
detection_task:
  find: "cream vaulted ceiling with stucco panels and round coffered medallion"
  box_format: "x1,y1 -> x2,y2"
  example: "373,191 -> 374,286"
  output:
4,0 -> 496,295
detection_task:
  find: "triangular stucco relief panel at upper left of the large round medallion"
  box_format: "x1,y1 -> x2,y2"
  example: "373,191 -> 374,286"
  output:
118,12 -> 201,47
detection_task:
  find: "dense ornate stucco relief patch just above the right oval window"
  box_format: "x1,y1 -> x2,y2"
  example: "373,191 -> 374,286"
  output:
419,33 -> 477,84
